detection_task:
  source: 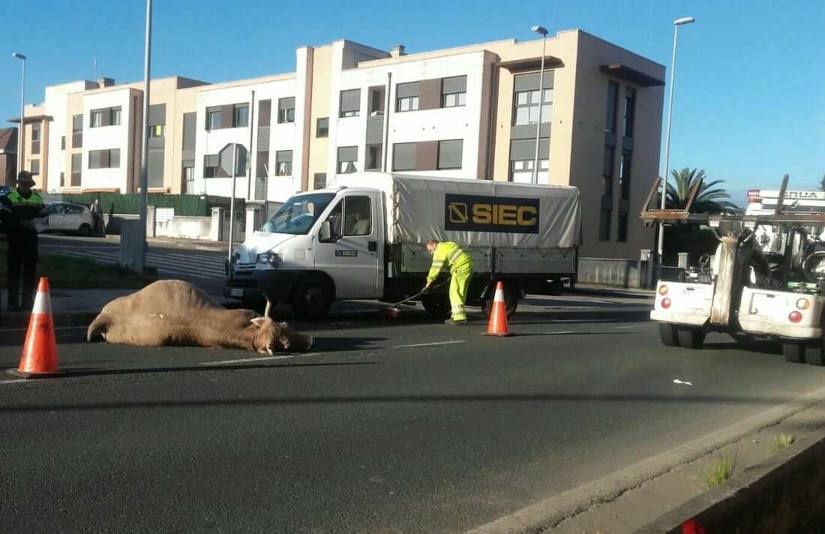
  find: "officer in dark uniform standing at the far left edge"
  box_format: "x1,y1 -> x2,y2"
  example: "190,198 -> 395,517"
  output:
0,171 -> 49,311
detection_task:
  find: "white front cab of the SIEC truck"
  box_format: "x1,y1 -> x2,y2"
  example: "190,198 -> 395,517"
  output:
225,187 -> 385,319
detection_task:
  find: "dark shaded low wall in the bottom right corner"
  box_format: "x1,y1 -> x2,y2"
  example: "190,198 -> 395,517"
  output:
637,432 -> 825,534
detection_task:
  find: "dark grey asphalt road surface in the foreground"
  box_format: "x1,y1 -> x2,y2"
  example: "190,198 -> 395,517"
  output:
0,293 -> 825,532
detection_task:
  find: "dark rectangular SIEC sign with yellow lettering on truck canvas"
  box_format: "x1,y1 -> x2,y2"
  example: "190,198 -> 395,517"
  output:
444,194 -> 540,234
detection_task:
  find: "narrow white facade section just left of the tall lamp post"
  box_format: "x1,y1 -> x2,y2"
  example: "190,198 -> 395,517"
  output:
82,87 -> 134,193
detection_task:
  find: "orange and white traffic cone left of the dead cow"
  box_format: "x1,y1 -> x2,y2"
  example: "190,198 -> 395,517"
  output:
9,277 -> 61,378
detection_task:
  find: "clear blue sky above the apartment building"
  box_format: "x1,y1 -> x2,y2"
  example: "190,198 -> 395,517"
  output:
0,0 -> 825,201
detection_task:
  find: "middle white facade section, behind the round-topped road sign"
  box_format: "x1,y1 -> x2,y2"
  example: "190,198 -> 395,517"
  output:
195,79 -> 300,200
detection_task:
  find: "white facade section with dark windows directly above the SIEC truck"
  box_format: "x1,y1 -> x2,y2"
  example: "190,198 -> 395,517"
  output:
327,52 -> 484,182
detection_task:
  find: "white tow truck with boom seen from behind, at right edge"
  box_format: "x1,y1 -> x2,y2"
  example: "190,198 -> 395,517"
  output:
642,176 -> 825,365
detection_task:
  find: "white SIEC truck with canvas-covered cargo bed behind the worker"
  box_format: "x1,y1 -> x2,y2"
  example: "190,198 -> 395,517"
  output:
225,173 -> 580,319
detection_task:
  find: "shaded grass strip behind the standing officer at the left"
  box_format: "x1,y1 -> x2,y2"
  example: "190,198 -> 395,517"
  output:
0,241 -> 156,289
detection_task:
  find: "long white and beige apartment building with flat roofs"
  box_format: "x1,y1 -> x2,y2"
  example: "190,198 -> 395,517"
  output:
17,30 -> 664,258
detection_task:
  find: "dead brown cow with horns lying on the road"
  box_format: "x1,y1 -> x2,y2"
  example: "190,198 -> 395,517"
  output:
86,280 -> 312,354
